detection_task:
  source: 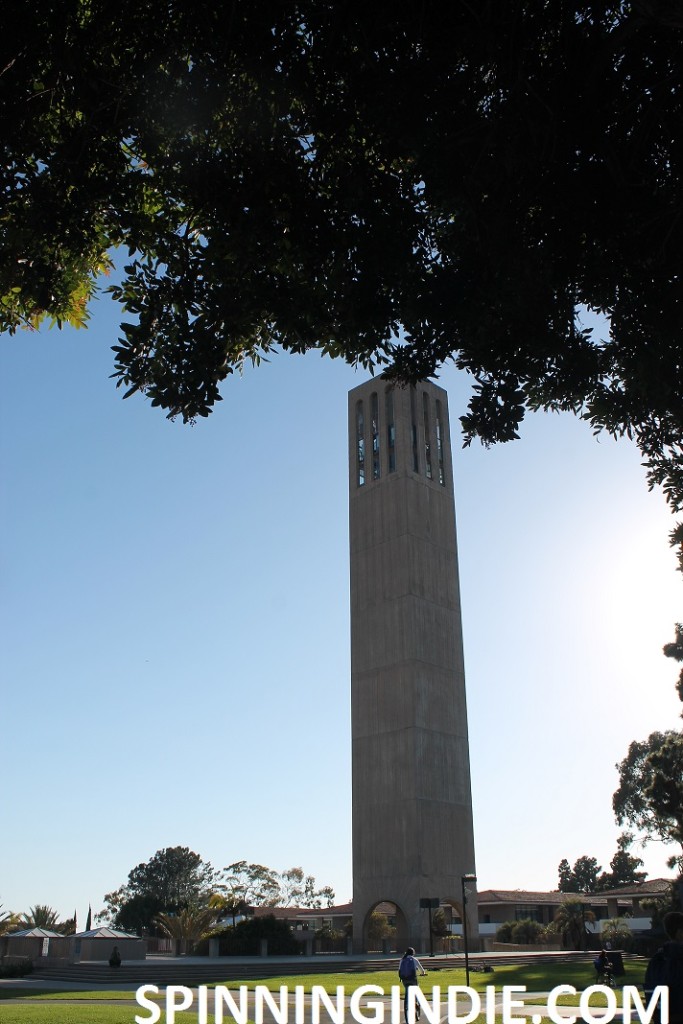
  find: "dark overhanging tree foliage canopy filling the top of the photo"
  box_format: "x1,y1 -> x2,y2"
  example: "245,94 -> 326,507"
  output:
0,0 -> 683,505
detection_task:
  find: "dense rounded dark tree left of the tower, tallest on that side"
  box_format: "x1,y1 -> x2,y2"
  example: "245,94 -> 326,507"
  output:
104,846 -> 216,932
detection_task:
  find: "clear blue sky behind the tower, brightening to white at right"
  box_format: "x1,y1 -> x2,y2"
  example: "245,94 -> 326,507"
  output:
0,299 -> 682,924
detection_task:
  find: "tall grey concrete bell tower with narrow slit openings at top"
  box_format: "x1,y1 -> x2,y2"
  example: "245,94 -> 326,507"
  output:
348,378 -> 478,952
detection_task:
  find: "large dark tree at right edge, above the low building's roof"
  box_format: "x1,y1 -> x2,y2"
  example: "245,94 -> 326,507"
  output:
612,731 -> 683,866
